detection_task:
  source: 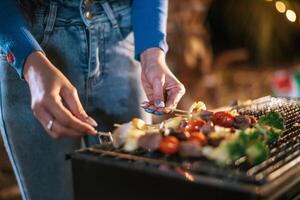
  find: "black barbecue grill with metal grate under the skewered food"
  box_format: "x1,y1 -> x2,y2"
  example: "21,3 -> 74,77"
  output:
70,97 -> 300,200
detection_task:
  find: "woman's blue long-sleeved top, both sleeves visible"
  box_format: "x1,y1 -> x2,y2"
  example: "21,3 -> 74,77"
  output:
0,0 -> 168,78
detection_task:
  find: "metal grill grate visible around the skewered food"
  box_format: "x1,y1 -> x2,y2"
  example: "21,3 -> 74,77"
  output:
89,97 -> 300,188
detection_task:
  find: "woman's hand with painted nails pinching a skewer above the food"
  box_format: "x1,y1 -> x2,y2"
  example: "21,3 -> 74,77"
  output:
141,48 -> 185,115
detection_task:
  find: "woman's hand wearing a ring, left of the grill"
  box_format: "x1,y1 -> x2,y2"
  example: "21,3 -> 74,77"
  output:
23,52 -> 97,138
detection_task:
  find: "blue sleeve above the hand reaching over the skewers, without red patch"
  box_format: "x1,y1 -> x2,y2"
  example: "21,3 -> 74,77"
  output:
132,0 -> 168,60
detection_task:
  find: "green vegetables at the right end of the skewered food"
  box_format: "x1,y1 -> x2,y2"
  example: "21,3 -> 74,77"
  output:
208,113 -> 284,165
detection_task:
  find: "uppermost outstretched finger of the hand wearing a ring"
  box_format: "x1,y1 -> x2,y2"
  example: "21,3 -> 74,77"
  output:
61,87 -> 98,127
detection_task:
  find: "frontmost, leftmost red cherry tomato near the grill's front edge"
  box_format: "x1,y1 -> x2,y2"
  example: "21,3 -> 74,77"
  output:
159,136 -> 180,154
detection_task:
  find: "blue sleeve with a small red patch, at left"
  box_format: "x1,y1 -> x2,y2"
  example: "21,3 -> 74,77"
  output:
0,0 -> 42,78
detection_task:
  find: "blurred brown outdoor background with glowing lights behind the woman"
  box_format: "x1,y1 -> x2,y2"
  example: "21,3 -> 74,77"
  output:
0,0 -> 300,200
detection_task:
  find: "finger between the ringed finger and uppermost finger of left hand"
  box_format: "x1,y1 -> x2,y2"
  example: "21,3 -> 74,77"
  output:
44,98 -> 97,135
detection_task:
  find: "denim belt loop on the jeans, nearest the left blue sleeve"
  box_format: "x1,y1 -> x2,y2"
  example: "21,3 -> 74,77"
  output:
41,2 -> 57,46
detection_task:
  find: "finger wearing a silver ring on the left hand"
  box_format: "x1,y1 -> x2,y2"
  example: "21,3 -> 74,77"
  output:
34,107 -> 84,138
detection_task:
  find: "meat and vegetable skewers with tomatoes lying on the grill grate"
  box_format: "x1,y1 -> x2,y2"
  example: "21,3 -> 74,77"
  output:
98,99 -> 286,165
